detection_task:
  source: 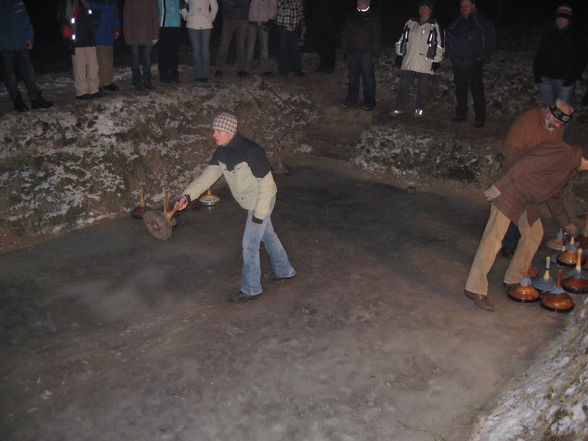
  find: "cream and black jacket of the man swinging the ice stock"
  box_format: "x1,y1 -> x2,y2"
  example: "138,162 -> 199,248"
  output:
184,132 -> 278,221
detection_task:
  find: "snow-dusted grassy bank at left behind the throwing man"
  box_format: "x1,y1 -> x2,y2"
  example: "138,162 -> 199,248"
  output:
0,78 -> 315,249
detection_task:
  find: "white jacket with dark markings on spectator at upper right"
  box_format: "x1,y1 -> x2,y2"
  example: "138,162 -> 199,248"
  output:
396,18 -> 445,74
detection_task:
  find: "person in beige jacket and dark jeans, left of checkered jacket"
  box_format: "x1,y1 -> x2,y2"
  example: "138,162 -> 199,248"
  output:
246,0 -> 278,75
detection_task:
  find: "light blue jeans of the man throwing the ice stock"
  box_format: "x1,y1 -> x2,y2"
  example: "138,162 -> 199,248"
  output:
241,197 -> 296,296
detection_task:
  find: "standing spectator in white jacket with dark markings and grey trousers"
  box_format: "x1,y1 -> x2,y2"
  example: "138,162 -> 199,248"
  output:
390,0 -> 445,118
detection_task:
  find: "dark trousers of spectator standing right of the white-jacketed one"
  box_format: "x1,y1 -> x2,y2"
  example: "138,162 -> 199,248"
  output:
453,61 -> 486,122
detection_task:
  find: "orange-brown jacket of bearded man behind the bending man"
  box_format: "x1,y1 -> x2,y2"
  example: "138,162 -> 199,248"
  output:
502,107 -> 563,168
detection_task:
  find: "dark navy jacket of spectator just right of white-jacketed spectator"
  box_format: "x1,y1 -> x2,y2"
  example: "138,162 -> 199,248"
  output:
447,11 -> 496,67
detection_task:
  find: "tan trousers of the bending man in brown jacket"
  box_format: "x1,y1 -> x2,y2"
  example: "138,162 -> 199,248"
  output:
465,204 -> 543,295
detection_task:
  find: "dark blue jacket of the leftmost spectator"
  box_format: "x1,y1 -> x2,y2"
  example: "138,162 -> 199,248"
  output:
0,0 -> 35,51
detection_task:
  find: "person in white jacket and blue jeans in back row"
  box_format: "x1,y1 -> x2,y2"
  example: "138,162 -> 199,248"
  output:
182,0 -> 218,83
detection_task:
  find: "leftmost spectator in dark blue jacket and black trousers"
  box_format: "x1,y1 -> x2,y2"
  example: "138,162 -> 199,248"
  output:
0,0 -> 53,112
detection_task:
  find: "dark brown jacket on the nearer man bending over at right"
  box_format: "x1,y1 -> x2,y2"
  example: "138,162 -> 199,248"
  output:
493,141 -> 582,227
